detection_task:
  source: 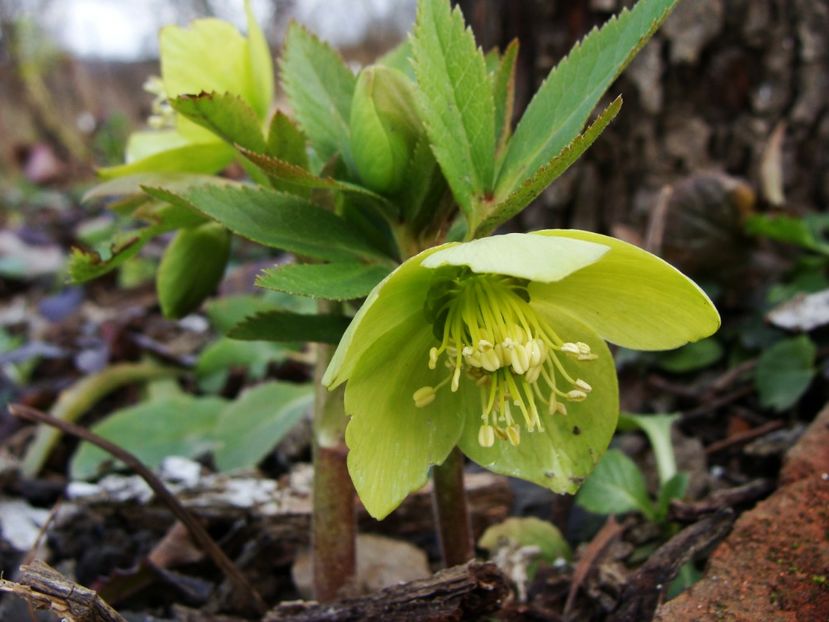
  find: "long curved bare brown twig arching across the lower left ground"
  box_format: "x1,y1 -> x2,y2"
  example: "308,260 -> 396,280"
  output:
9,404 -> 267,614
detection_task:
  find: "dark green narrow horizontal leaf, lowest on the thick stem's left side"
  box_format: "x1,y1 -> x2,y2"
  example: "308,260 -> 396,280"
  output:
228,311 -> 350,344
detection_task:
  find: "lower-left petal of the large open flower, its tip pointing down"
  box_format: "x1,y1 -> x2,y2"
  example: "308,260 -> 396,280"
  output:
345,319 -> 472,520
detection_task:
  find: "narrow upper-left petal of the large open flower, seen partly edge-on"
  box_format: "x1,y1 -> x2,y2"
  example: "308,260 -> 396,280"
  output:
322,245 -> 445,389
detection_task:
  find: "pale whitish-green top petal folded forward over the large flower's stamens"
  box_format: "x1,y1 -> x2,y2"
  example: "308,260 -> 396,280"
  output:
422,233 -> 609,283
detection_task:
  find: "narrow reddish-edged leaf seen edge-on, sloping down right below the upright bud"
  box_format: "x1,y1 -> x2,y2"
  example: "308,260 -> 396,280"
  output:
240,149 -> 397,218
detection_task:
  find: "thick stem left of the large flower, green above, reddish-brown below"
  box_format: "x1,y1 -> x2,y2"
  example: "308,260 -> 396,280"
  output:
311,301 -> 356,602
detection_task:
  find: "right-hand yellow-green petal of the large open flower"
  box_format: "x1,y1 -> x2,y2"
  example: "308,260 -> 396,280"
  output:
530,230 -> 720,350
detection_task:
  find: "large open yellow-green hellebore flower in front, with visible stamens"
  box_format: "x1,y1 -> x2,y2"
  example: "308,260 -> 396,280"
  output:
323,230 -> 720,518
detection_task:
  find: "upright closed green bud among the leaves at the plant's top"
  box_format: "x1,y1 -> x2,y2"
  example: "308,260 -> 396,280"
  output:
351,66 -> 423,194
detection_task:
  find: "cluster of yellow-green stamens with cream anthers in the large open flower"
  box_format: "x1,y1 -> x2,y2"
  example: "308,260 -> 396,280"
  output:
412,268 -> 596,447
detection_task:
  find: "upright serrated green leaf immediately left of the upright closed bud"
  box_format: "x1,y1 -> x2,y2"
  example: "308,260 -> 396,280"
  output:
281,22 -> 356,167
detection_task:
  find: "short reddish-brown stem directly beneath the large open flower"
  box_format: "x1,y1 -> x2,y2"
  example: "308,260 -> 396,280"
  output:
432,448 -> 468,568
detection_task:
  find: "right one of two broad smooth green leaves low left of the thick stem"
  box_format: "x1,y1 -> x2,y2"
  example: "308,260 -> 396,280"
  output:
213,382 -> 314,471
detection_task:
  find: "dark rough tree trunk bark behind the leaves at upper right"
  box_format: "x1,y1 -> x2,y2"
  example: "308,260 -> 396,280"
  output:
460,0 -> 829,247
